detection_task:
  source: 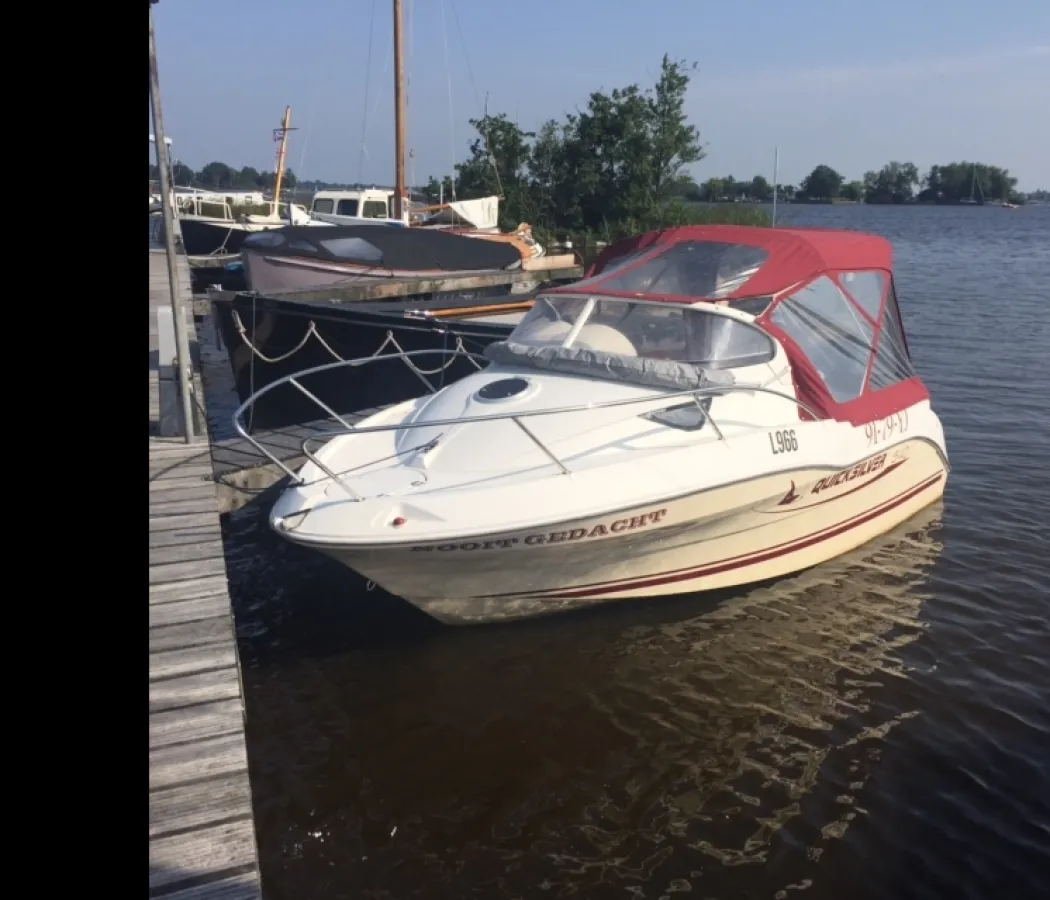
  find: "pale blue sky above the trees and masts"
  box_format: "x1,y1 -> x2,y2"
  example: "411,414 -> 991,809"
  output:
153,0 -> 1050,190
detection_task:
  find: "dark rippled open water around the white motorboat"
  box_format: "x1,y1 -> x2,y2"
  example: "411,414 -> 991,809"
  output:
215,206 -> 1050,900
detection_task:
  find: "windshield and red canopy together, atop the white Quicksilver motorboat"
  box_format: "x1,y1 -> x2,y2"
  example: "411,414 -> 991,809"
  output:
497,226 -> 929,424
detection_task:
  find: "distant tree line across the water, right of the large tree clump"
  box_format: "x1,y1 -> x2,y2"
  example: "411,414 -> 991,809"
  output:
679,161 -> 1029,204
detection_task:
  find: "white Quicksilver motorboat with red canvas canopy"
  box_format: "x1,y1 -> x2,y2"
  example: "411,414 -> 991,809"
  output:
243,226 -> 948,624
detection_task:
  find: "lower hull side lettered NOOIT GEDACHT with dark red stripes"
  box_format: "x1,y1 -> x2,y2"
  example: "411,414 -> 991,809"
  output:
285,436 -> 947,624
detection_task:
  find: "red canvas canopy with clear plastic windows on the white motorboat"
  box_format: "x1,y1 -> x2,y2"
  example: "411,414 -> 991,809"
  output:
550,225 -> 929,425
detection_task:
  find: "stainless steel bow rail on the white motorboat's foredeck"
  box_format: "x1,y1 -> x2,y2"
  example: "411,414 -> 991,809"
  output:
233,349 -> 821,500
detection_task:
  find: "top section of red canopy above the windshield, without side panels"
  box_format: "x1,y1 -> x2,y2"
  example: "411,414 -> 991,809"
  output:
554,225 -> 893,304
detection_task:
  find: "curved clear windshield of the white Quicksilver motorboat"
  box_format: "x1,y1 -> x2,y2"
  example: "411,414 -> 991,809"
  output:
508,295 -> 776,369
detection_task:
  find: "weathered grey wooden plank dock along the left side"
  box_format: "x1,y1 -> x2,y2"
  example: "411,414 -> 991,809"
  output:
149,251 -> 260,900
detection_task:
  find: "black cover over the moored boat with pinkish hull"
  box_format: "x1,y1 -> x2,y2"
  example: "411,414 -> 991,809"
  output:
243,224 -> 522,272
